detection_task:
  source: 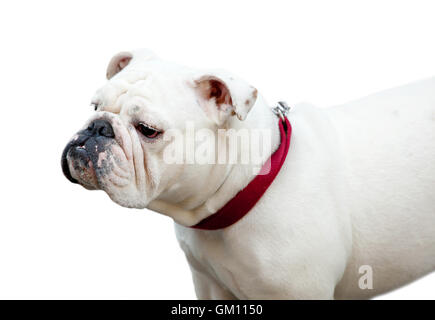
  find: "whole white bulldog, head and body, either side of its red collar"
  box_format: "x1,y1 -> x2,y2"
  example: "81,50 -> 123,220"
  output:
62,51 -> 435,299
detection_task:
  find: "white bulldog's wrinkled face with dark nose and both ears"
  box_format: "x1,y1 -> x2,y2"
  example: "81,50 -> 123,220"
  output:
62,51 -> 257,212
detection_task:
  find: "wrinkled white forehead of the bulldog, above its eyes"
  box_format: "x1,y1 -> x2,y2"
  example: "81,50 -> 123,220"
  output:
92,61 -> 192,114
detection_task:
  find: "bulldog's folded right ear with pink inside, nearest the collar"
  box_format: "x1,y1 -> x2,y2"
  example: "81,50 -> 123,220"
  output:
194,73 -> 257,125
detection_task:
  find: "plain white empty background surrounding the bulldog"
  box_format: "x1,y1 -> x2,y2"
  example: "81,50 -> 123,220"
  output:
0,0 -> 435,299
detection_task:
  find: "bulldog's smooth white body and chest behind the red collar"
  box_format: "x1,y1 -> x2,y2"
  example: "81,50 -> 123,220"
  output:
176,79 -> 435,299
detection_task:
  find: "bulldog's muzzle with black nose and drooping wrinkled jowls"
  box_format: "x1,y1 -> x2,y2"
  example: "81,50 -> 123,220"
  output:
61,106 -> 153,207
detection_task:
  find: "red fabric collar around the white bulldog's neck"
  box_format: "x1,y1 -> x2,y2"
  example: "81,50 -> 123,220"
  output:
191,117 -> 292,230
